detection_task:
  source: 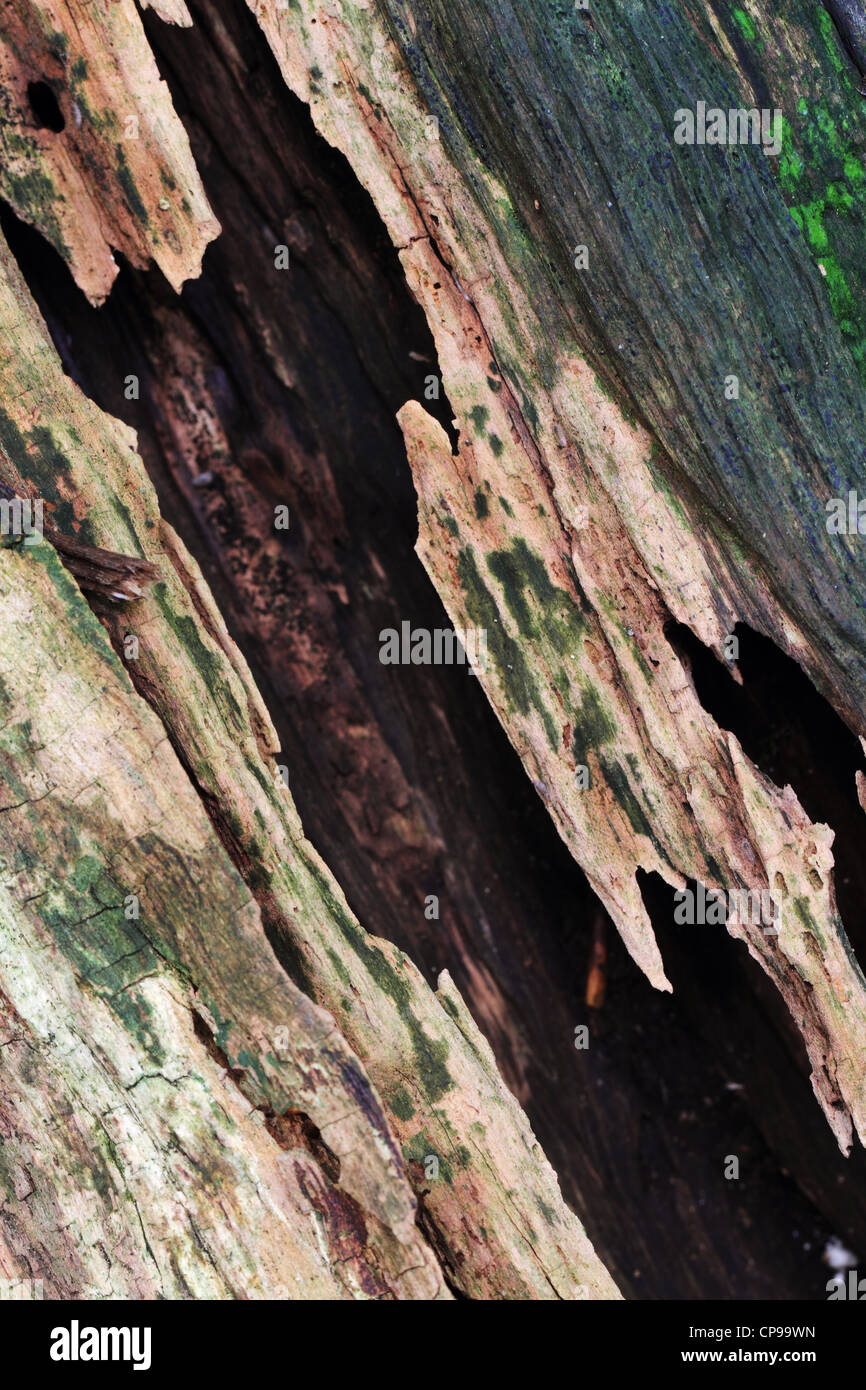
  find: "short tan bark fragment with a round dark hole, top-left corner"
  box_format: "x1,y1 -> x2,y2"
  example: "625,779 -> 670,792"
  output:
0,0 -> 220,303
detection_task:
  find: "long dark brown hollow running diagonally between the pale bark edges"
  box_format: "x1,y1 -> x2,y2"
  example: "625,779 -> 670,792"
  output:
4,0 -> 866,1298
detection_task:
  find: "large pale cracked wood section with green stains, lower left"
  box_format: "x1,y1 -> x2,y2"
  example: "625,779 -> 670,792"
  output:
0,2 -> 616,1298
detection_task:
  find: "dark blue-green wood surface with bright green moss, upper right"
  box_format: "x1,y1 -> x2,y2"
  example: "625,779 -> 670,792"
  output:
382,0 -> 866,720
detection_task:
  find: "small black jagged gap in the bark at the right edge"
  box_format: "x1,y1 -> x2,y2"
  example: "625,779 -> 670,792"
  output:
664,623 -> 866,962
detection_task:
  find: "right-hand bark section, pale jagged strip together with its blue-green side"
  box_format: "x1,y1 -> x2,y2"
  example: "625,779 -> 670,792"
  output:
241,0 -> 866,1148
